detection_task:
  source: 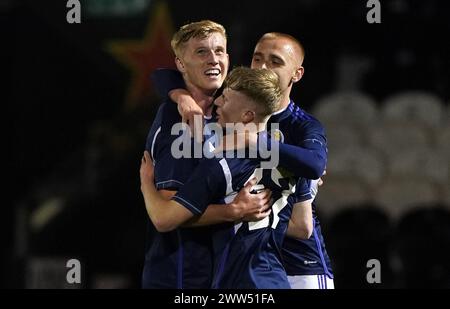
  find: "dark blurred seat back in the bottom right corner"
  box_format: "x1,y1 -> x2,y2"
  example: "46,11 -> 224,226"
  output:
391,204 -> 450,289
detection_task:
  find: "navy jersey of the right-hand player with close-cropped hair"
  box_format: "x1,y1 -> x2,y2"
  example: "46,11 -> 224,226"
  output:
269,101 -> 333,278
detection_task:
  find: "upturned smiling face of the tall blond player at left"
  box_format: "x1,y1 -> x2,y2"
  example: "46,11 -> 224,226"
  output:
176,32 -> 229,94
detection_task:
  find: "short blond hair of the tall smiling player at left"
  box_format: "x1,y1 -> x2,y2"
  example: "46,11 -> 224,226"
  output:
170,20 -> 227,57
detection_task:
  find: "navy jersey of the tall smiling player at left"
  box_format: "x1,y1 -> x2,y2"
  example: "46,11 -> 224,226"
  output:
142,100 -> 213,289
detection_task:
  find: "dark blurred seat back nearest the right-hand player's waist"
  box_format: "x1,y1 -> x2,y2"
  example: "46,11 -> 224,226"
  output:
324,203 -> 393,288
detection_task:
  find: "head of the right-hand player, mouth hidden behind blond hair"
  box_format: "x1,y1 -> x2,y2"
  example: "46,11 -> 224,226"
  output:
251,35 -> 304,97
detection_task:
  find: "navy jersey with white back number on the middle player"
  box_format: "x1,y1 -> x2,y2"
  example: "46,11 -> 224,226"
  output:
173,131 -> 311,289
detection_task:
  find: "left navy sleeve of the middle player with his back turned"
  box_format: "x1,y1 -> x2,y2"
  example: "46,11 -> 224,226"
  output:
172,159 -> 227,215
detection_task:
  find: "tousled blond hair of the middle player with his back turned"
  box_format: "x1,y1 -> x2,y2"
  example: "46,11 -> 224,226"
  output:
224,67 -> 282,117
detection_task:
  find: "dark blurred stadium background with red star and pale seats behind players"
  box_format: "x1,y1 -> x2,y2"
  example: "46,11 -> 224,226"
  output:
5,0 -> 450,288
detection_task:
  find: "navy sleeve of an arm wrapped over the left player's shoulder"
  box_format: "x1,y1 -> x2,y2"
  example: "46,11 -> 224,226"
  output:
151,69 -> 186,98
